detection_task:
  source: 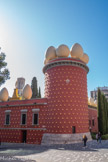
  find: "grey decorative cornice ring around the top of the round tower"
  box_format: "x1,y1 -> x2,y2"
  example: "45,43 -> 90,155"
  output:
43,59 -> 89,73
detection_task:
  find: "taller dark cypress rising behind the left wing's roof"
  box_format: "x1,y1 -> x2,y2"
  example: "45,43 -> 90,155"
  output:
31,77 -> 38,98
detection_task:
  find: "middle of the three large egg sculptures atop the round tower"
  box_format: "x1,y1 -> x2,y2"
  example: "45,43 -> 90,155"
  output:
56,44 -> 70,57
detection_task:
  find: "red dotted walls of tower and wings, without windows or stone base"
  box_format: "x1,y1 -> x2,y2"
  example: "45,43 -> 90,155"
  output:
0,58 -> 98,144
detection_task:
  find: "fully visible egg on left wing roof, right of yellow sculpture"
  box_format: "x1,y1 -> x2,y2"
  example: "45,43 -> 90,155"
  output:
23,84 -> 32,99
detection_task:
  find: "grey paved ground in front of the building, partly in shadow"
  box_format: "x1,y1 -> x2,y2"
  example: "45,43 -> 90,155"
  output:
0,140 -> 108,162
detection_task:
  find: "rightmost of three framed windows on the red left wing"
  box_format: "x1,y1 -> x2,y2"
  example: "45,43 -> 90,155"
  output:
32,109 -> 40,125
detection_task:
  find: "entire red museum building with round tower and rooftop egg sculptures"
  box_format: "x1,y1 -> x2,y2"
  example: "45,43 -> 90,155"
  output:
0,43 -> 98,144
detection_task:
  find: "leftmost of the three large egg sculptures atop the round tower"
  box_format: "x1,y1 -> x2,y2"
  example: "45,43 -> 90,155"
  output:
45,46 -> 57,60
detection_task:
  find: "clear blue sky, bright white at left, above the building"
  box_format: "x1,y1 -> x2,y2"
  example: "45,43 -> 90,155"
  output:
0,0 -> 108,96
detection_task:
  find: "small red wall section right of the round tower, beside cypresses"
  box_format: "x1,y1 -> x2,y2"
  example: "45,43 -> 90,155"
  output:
88,106 -> 98,132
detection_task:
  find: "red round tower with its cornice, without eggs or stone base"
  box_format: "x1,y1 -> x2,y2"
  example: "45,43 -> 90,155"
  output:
43,57 -> 89,144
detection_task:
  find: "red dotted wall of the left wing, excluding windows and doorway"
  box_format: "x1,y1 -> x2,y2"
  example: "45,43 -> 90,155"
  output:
0,99 -> 47,144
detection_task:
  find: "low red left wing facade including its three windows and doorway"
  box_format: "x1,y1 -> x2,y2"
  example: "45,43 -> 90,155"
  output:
0,98 -> 47,144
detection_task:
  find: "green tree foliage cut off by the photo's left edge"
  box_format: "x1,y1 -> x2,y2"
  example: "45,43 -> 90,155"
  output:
0,48 -> 10,86
